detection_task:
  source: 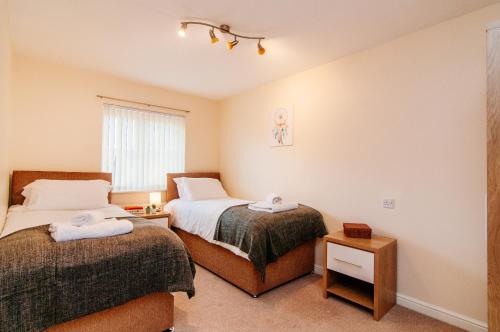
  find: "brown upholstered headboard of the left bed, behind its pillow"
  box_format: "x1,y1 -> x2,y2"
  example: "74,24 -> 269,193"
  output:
9,171 -> 113,205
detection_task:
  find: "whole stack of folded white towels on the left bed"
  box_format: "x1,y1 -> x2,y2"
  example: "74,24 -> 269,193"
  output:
49,211 -> 134,242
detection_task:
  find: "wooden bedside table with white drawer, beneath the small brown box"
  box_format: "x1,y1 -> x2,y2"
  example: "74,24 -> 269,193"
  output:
323,232 -> 397,320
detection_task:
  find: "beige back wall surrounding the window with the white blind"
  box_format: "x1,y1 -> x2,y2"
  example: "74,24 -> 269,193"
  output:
10,55 -> 218,204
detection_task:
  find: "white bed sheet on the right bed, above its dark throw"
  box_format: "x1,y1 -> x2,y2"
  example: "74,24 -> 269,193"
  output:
163,197 -> 252,259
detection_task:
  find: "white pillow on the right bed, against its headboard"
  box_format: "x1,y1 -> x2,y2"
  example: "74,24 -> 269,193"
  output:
174,178 -> 228,201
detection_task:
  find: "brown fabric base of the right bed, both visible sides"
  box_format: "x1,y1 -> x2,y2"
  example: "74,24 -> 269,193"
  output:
174,228 -> 316,297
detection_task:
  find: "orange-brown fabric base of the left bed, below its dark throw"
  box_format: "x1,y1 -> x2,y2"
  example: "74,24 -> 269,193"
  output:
47,293 -> 174,332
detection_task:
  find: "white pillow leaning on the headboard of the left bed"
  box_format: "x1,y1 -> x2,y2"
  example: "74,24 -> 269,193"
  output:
22,180 -> 111,210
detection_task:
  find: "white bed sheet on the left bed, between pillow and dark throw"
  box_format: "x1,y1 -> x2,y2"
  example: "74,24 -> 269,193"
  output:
0,205 -> 133,239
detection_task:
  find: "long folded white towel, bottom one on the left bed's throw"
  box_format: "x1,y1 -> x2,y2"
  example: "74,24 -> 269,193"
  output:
49,218 -> 134,242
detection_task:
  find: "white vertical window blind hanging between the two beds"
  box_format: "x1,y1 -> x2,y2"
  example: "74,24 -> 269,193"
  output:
101,104 -> 185,192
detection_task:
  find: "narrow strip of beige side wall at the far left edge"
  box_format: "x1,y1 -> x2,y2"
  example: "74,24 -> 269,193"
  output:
0,0 -> 11,232
